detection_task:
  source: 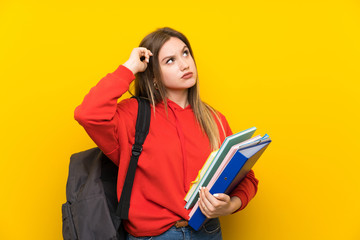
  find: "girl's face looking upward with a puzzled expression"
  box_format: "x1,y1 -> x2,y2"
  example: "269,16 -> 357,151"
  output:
159,37 -> 197,95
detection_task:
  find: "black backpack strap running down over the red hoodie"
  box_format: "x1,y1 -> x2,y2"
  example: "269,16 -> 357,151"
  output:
116,97 -> 151,219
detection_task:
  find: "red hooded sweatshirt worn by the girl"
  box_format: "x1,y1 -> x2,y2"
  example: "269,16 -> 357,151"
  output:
75,65 -> 258,236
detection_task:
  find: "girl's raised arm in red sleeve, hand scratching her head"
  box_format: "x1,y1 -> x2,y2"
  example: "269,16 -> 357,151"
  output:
74,48 -> 152,164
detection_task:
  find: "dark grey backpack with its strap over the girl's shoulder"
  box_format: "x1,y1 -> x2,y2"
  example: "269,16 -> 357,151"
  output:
62,97 -> 151,240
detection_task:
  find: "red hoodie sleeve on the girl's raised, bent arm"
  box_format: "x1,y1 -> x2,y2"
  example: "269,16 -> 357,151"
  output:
74,65 -> 137,165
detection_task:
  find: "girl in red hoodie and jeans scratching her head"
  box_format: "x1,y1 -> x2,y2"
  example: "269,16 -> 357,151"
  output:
75,28 -> 258,239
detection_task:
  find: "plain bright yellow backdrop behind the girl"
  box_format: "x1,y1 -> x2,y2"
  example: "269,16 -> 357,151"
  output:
0,0 -> 360,240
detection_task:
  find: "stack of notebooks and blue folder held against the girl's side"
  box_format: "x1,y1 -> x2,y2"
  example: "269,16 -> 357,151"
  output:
185,127 -> 271,230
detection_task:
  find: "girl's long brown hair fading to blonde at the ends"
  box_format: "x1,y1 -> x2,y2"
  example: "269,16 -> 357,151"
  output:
135,27 -> 225,150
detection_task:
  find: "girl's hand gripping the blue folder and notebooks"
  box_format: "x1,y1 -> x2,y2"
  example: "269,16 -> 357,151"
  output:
199,188 -> 241,218
